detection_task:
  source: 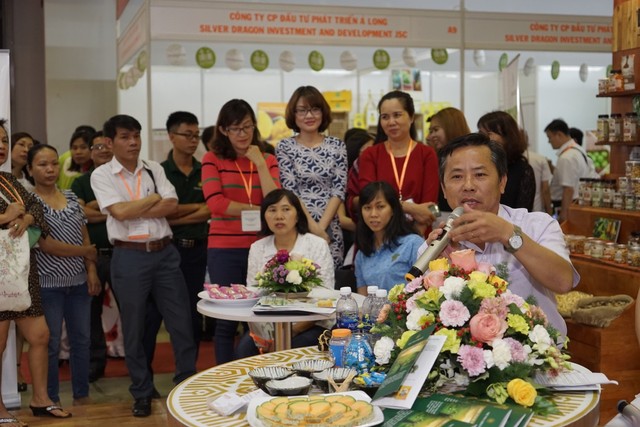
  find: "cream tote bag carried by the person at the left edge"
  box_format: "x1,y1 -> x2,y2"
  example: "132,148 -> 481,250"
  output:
0,230 -> 31,311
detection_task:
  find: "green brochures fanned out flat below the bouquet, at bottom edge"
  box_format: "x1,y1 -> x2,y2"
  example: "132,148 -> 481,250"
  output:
383,394 -> 516,427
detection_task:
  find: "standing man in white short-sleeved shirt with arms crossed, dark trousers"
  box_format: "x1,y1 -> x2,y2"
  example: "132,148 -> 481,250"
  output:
91,115 -> 196,417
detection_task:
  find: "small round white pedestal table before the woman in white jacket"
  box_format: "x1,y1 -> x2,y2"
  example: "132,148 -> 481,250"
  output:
198,300 -> 335,351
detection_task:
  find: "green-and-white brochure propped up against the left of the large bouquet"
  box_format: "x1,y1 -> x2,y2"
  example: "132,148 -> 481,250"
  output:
372,326 -> 446,409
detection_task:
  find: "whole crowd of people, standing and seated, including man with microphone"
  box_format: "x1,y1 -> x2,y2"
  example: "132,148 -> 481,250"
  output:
0,86 -> 593,423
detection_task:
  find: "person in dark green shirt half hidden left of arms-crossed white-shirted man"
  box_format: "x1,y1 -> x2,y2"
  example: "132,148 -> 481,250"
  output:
71,131 -> 113,382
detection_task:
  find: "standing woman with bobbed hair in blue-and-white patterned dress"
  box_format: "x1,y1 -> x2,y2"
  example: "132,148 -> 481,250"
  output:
276,86 -> 347,267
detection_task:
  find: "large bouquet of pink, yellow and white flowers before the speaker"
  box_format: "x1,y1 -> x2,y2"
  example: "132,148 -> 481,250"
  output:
371,249 -> 570,414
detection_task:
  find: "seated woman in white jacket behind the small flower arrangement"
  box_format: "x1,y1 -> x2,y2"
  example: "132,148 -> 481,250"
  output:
236,189 -> 334,359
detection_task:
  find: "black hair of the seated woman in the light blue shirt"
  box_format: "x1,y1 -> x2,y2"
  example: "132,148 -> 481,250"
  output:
356,181 -> 415,256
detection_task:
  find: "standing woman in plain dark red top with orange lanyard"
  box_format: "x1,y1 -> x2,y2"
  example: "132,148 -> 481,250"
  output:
354,91 -> 439,237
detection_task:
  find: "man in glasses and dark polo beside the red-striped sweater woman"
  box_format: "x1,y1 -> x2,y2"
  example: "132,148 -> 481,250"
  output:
144,111 -> 211,372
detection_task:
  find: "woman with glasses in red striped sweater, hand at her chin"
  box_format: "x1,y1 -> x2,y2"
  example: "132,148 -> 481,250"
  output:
202,99 -> 280,364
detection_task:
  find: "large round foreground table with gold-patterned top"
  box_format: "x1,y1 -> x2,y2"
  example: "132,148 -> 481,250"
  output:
167,347 -> 600,427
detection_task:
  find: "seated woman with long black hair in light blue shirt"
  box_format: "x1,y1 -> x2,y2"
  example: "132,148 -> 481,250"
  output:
356,181 -> 424,295
